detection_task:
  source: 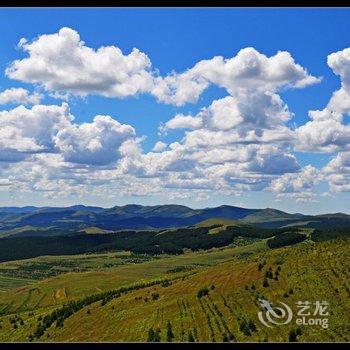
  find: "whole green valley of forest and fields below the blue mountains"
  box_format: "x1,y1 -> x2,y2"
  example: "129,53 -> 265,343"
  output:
0,204 -> 350,342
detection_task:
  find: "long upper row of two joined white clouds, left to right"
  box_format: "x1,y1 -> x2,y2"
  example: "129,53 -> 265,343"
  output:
6,27 -> 320,106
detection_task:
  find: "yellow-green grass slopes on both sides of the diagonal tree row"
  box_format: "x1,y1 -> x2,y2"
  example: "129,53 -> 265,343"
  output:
0,238 -> 350,342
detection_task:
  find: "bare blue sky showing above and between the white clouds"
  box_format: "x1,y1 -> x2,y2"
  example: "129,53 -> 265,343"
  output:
0,9 -> 350,213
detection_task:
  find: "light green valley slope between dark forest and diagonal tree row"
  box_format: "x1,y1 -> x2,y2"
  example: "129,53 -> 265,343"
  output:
0,241 -> 267,313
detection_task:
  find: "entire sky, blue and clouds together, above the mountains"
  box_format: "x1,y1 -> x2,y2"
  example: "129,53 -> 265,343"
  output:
0,8 -> 350,214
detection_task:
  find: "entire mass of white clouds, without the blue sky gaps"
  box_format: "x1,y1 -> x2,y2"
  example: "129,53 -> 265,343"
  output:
0,28 -> 350,202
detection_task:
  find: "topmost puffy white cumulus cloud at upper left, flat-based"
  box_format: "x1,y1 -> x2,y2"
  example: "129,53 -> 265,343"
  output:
6,28 -> 152,97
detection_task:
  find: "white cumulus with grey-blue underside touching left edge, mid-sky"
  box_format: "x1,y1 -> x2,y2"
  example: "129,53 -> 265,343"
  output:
0,103 -> 135,165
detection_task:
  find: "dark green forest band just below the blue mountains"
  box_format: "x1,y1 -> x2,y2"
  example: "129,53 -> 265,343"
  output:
0,225 -> 350,262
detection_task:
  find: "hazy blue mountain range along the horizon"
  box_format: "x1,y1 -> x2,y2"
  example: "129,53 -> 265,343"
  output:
0,204 -> 350,236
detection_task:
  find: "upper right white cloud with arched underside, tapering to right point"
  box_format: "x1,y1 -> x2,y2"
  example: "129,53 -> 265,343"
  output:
152,47 -> 320,106
